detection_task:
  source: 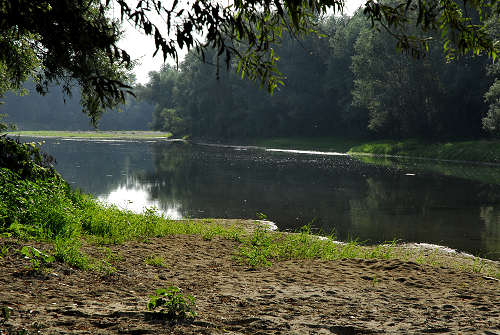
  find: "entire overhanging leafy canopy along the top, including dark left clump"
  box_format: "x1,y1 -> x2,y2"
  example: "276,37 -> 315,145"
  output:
0,0 -> 500,122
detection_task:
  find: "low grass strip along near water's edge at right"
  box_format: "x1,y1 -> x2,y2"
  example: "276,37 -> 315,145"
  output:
235,226 -> 500,279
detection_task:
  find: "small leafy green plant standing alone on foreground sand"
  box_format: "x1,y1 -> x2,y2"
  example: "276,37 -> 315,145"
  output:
147,286 -> 196,320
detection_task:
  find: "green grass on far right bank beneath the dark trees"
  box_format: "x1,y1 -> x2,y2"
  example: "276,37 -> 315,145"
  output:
349,139 -> 500,163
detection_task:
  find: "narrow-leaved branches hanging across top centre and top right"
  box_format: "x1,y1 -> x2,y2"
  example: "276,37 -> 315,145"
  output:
117,0 -> 499,90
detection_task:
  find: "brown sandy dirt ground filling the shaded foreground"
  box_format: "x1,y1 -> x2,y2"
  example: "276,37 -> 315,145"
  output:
0,236 -> 500,335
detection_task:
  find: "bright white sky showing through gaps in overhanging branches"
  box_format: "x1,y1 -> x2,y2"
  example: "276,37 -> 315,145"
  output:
119,0 -> 365,84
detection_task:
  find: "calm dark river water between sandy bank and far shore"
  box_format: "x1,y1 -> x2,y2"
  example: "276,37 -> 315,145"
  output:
29,139 -> 500,259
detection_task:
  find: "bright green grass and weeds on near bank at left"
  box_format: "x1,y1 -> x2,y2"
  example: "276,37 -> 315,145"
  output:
0,168 -> 245,269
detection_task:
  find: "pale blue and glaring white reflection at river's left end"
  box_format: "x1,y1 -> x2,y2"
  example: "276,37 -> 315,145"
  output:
40,140 -> 180,218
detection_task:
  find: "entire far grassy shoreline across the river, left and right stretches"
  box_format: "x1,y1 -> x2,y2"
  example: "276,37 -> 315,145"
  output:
7,130 -> 500,165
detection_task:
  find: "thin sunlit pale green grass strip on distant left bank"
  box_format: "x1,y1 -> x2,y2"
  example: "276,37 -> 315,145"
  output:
8,130 -> 172,139
